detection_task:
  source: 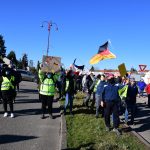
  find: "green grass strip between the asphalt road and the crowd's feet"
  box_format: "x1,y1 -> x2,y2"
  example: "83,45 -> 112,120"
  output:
59,93 -> 148,150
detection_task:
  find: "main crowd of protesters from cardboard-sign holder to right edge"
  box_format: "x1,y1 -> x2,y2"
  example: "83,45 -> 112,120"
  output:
39,64 -> 150,133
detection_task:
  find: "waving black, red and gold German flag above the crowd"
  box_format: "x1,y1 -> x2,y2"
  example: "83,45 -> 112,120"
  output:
90,41 -> 116,65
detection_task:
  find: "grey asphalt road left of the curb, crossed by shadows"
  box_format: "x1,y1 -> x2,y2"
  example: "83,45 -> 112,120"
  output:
0,81 -> 61,150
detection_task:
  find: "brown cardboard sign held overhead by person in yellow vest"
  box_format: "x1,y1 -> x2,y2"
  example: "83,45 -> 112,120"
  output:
41,56 -> 61,73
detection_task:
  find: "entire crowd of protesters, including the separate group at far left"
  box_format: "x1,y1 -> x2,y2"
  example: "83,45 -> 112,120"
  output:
0,62 -> 150,134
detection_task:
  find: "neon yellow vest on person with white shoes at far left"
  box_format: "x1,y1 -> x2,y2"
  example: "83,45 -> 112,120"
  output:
1,77 -> 14,91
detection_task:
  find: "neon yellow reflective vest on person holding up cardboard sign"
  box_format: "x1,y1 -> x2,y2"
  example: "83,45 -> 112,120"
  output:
40,78 -> 55,96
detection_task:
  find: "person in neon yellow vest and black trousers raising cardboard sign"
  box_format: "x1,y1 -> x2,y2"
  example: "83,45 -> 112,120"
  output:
40,72 -> 55,119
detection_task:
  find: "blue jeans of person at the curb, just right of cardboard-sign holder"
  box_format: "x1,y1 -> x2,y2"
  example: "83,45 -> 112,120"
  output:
64,93 -> 73,113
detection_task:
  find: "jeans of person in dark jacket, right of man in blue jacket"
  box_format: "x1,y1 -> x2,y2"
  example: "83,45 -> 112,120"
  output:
125,104 -> 136,123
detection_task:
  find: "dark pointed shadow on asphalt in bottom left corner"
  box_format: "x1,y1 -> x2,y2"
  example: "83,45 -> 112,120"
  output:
0,135 -> 38,144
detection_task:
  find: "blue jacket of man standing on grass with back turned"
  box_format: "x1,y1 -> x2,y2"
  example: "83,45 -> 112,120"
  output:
102,83 -> 119,102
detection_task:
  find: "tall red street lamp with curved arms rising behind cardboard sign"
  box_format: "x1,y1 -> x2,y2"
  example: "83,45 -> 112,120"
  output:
41,21 -> 58,56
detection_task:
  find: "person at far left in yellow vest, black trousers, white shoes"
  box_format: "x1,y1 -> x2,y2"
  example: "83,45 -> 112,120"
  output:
1,67 -> 14,118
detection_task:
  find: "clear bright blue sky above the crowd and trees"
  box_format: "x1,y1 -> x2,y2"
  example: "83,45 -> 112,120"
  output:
0,0 -> 150,69
